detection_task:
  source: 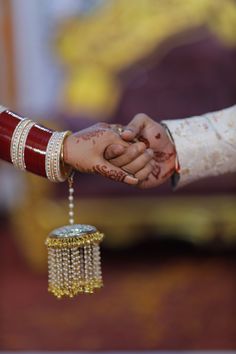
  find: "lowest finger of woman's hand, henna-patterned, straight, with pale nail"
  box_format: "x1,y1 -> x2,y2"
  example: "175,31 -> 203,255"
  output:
93,160 -> 138,185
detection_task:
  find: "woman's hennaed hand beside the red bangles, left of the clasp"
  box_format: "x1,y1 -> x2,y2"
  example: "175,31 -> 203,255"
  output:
63,123 -> 153,185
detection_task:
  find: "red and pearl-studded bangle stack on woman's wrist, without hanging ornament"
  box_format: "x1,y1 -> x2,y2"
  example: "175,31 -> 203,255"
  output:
0,106 -> 72,182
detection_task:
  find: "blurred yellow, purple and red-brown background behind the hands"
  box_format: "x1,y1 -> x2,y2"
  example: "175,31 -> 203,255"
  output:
0,0 -> 236,350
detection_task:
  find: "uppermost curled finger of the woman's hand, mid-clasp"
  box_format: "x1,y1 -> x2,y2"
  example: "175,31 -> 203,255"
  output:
106,142 -> 146,167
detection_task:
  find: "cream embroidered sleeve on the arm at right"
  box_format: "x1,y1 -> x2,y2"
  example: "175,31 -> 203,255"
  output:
162,105 -> 236,187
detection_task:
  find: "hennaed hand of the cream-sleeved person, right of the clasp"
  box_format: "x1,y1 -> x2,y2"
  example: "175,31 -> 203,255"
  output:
105,113 -> 176,188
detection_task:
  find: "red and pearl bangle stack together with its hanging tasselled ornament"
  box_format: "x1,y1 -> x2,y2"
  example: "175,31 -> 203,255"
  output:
0,106 -> 107,298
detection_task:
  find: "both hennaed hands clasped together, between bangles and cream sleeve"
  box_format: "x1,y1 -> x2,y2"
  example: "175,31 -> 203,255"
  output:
64,114 -> 176,188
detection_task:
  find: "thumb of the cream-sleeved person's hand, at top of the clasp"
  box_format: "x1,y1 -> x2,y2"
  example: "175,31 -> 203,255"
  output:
121,113 -> 150,141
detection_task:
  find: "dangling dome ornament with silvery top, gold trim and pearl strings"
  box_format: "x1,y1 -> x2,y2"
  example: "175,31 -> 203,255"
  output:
46,224 -> 104,298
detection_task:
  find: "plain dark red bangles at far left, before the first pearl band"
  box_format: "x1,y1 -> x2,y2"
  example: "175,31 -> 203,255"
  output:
0,110 -> 23,162
